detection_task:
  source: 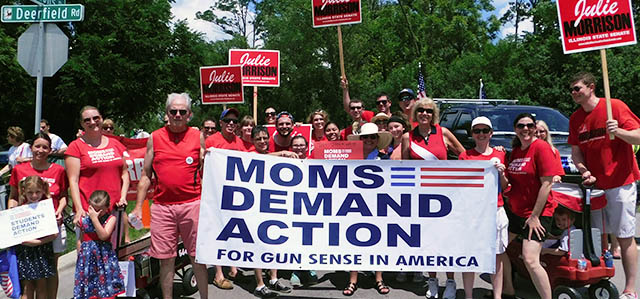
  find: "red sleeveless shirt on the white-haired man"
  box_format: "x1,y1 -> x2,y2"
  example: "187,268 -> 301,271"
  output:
151,127 -> 201,205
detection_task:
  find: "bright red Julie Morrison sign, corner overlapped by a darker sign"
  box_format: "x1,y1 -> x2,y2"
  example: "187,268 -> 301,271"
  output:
229,49 -> 280,87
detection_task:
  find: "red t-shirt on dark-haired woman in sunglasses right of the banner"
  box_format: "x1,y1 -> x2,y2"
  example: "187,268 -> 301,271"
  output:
505,139 -> 563,218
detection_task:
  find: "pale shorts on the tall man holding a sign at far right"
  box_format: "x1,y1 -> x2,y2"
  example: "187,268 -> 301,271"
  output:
591,182 -> 637,238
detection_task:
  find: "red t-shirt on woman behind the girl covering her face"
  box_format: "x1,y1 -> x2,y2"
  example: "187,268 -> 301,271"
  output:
64,138 -> 128,211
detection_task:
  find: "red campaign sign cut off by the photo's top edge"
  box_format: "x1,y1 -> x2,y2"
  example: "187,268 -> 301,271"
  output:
311,0 -> 362,28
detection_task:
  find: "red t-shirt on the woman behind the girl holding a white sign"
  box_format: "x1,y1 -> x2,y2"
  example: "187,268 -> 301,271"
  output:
9,163 -> 69,211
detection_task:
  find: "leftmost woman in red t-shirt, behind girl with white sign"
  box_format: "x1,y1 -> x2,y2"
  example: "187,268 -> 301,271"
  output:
8,133 -> 69,298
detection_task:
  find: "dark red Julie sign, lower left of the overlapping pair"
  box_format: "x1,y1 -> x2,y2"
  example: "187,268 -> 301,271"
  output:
200,65 -> 244,104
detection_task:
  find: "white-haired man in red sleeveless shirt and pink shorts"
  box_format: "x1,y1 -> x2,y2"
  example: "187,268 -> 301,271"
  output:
132,93 -> 208,299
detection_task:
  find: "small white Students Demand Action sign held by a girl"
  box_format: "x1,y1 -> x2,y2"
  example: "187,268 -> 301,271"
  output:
0,199 -> 58,248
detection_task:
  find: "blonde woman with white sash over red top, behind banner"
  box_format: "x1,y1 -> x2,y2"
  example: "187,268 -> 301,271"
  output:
402,98 -> 464,299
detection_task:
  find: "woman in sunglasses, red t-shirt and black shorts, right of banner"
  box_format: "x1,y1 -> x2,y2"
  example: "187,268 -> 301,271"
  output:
505,113 -> 564,299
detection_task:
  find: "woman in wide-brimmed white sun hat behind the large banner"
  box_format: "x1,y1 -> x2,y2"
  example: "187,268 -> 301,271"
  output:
342,123 -> 393,296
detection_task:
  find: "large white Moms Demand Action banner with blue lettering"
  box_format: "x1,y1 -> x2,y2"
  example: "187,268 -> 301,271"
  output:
196,149 -> 498,273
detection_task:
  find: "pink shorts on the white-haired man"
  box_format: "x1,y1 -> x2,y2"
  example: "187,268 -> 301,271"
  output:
149,200 -> 200,259
